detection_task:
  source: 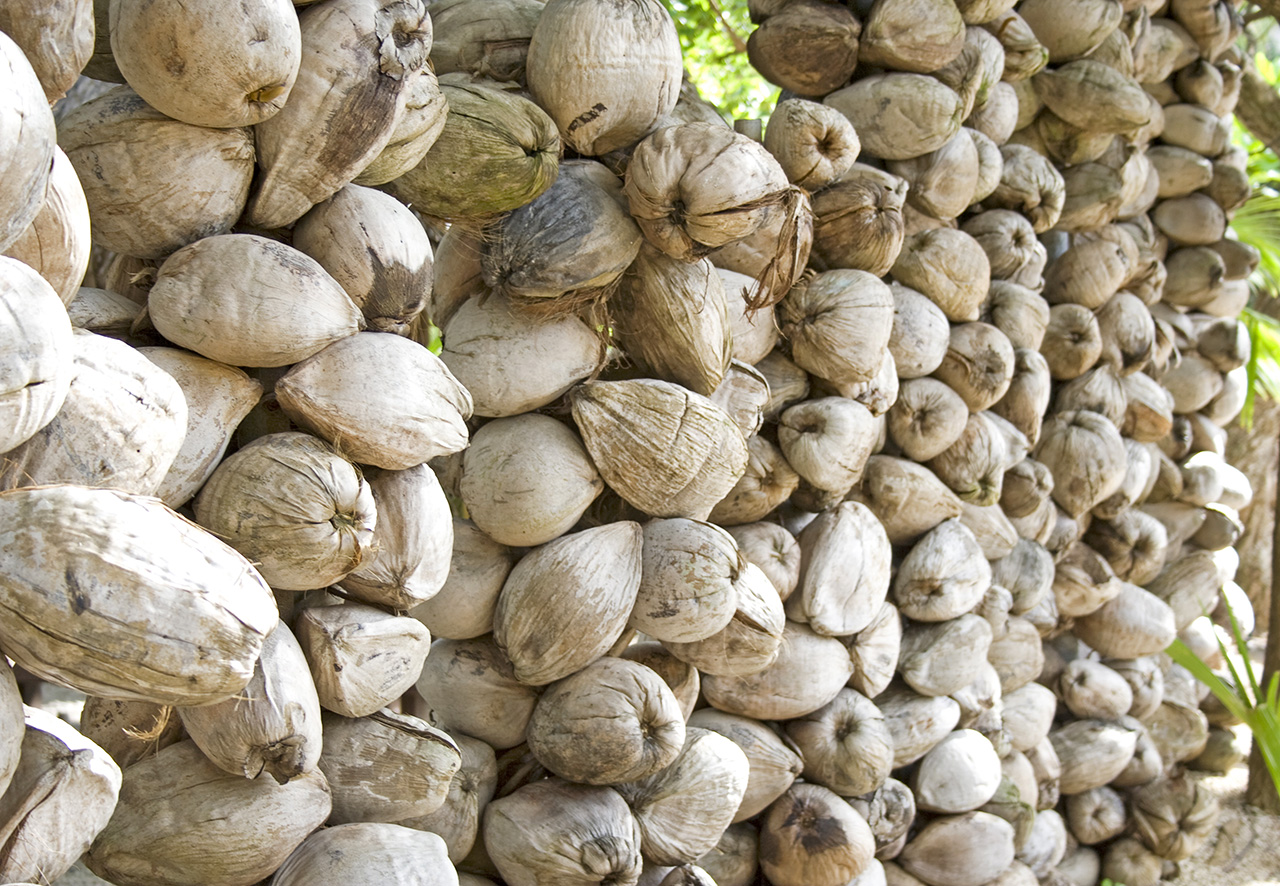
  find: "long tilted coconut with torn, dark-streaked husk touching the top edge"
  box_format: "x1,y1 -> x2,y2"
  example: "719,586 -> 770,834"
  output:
244,0 -> 431,229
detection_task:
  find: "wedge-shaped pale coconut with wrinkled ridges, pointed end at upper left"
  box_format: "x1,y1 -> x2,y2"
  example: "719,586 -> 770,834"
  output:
571,379 -> 748,520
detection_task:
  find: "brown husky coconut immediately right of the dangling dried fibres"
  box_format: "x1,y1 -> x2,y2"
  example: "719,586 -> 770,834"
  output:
810,163 -> 908,277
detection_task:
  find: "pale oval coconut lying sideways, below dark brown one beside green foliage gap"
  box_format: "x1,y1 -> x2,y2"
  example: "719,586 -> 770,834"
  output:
823,73 -> 968,160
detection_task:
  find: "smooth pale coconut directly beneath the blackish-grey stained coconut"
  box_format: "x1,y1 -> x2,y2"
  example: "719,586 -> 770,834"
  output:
440,289 -> 604,416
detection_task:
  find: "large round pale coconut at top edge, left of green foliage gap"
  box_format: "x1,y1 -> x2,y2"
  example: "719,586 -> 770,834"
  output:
526,0 -> 682,155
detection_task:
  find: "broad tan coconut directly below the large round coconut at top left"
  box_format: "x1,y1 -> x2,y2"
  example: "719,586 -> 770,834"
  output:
57,86 -> 255,259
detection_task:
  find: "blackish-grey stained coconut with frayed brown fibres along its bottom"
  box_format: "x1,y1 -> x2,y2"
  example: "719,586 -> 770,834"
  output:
481,160 -> 640,311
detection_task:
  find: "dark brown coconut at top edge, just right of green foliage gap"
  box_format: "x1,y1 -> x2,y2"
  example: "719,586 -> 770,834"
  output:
746,0 -> 861,97
